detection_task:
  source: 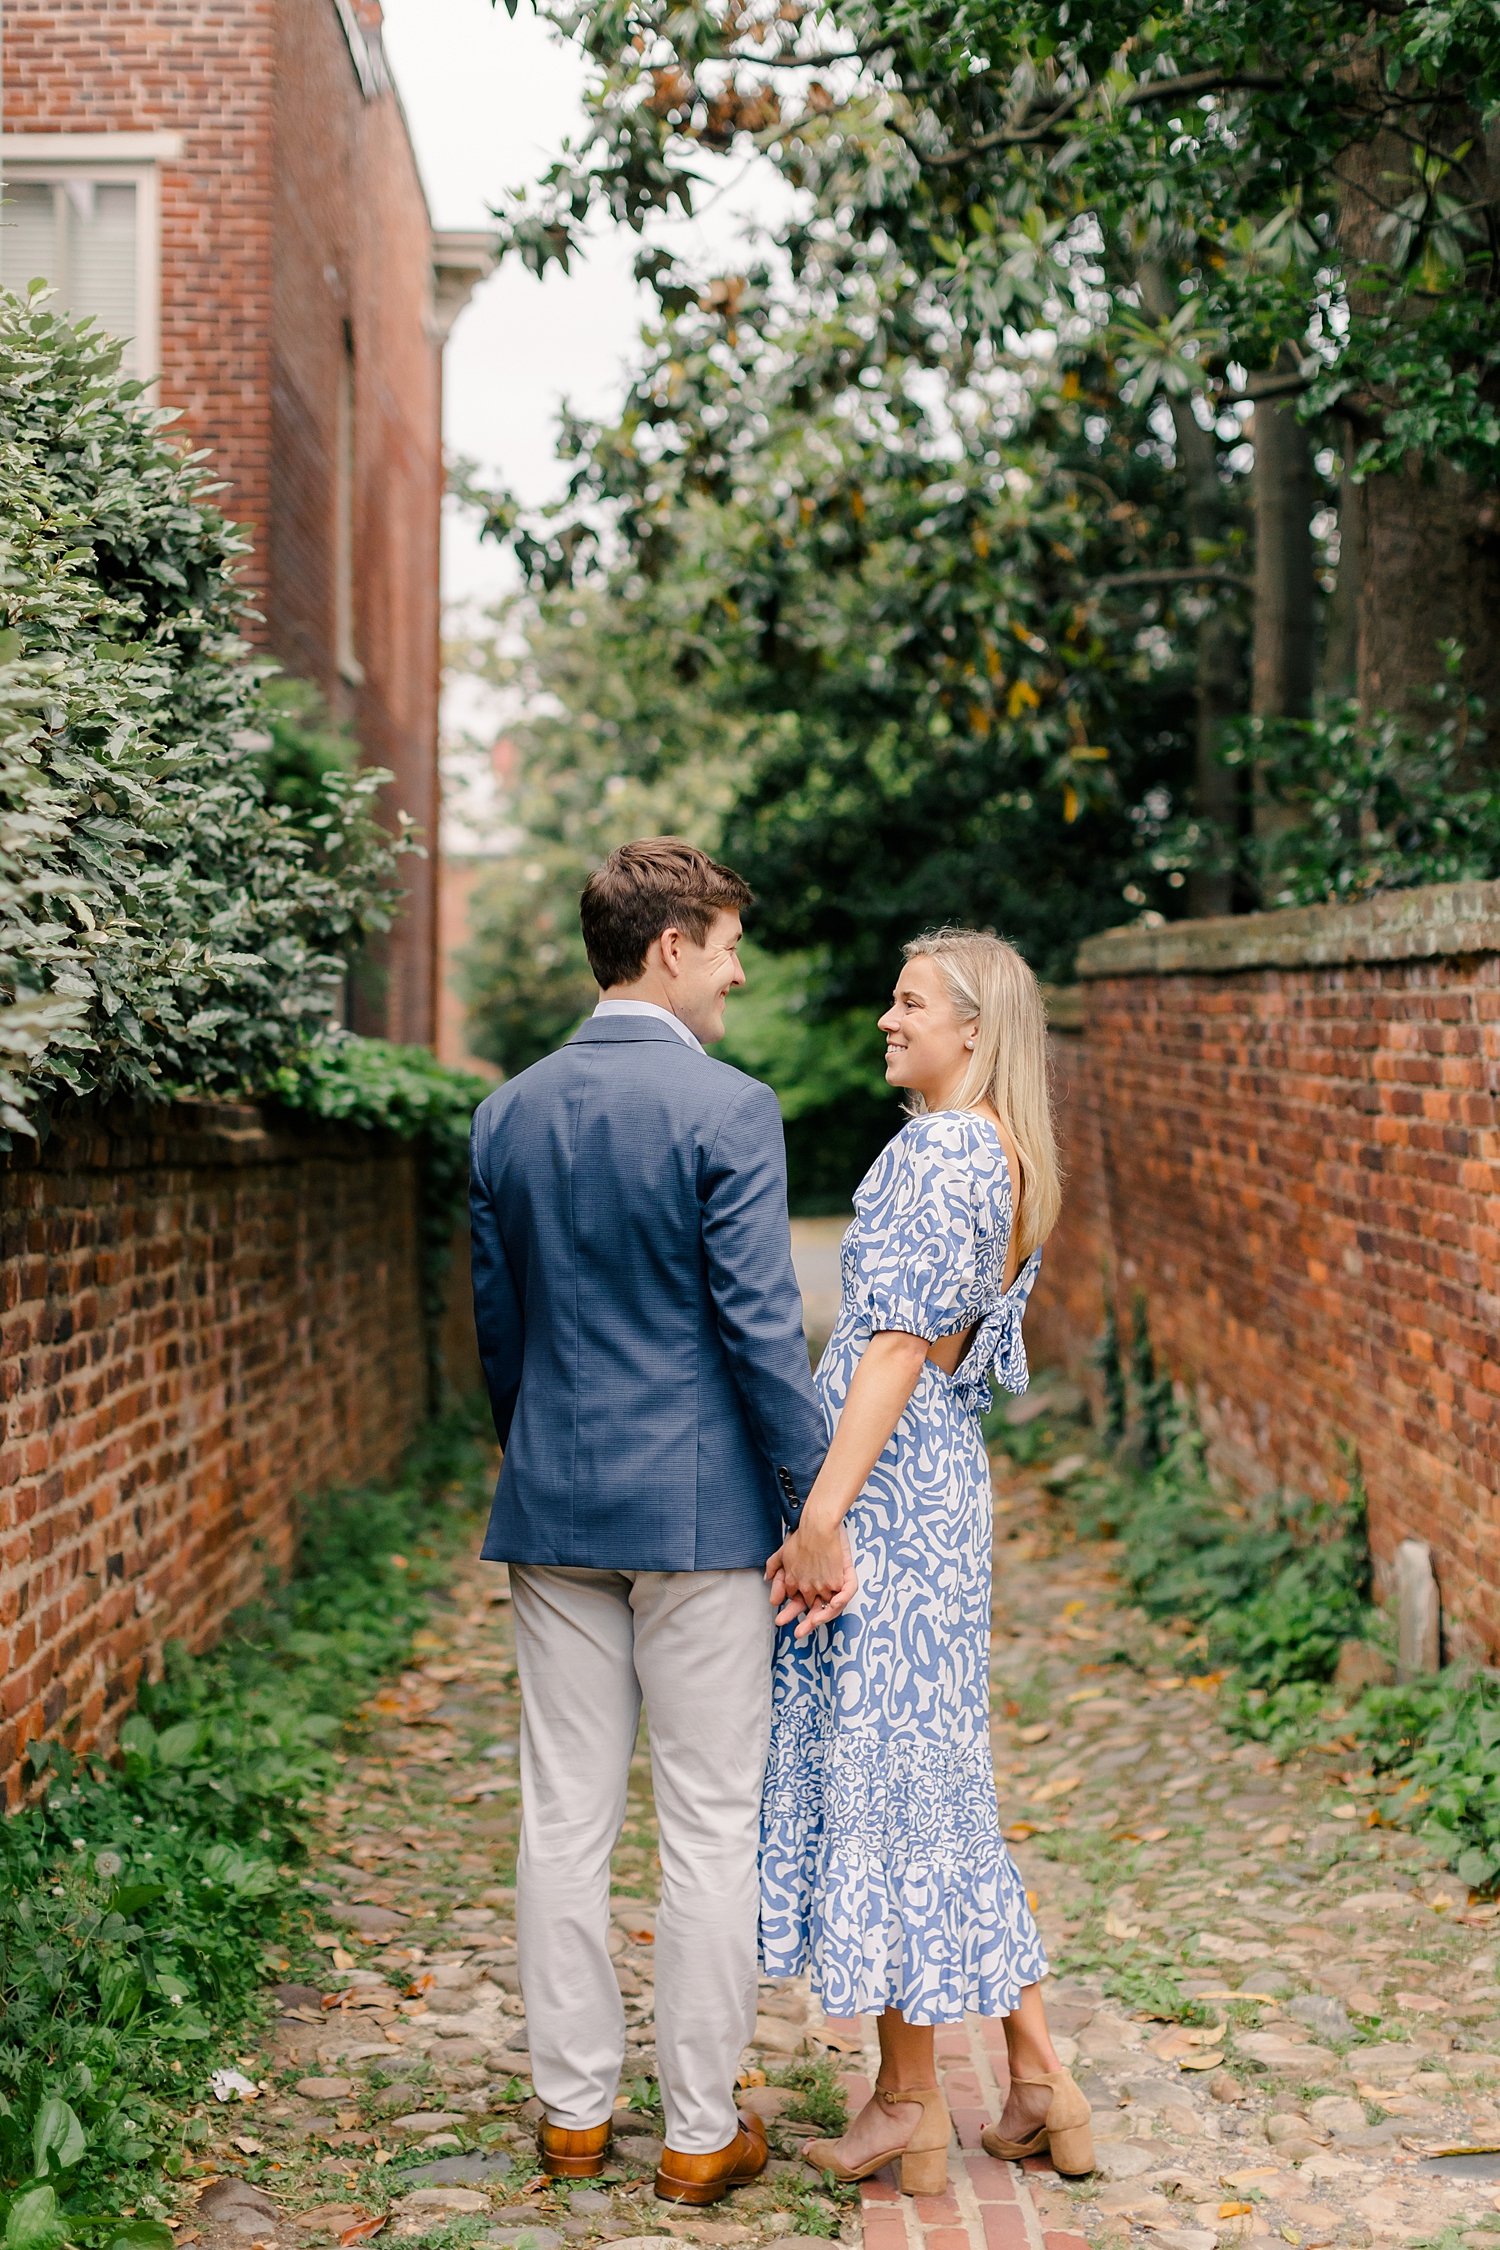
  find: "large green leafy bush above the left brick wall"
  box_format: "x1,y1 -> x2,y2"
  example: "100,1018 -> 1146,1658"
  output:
0,295 -> 409,1134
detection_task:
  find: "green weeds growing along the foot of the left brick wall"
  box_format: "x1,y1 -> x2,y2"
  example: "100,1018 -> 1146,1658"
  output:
0,1422 -> 486,2250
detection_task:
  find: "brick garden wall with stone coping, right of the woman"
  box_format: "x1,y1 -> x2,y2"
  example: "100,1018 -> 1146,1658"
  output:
1028,884 -> 1500,1656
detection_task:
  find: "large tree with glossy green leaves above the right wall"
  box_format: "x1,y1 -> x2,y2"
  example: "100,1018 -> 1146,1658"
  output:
479,0 -> 1500,945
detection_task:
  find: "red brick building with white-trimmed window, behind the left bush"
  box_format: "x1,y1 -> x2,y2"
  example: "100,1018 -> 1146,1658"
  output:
0,0 -> 486,1044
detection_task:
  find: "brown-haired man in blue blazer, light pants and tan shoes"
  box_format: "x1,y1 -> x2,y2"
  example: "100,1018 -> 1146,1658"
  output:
472,837 -> 852,2203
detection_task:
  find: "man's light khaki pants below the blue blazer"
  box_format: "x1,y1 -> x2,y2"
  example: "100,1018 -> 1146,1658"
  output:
510,1564 -> 771,2156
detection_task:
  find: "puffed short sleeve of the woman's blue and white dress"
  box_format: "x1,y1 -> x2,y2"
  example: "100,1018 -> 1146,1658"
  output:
855,1116 -> 981,1343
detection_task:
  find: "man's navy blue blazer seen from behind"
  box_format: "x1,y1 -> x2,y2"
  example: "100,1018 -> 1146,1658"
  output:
470,1015 -> 828,1571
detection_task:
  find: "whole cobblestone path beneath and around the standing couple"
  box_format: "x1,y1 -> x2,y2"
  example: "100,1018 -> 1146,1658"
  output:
178,1413 -> 1500,2250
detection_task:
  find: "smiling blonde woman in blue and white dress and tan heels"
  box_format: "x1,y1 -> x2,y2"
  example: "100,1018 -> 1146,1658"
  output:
760,929 -> 1093,2194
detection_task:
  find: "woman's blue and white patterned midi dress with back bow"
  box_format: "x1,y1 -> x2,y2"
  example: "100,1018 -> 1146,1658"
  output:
760,1109 -> 1046,2023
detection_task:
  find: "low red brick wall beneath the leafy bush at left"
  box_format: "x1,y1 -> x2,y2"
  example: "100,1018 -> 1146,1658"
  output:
0,1105 -> 425,1802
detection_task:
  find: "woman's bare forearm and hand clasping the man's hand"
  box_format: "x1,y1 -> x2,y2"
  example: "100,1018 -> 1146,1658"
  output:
765,1330 -> 927,1640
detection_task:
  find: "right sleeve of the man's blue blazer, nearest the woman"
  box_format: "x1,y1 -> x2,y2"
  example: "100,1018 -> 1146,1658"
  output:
702,1082 -> 828,1523
